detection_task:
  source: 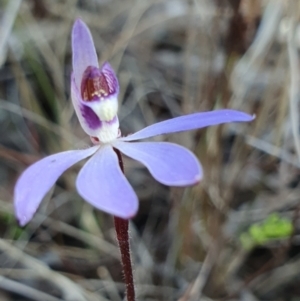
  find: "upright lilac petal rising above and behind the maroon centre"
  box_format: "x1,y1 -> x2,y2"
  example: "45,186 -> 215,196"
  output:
72,19 -> 99,88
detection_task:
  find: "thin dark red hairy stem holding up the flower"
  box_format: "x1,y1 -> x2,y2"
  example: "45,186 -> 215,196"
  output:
114,148 -> 135,301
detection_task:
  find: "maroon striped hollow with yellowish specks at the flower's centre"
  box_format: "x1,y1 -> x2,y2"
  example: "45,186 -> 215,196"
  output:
81,66 -> 110,101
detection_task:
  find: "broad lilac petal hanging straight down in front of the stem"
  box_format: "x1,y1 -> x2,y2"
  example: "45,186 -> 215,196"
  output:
76,145 -> 138,219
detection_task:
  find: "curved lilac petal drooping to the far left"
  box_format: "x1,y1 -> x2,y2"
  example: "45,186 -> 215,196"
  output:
14,146 -> 99,226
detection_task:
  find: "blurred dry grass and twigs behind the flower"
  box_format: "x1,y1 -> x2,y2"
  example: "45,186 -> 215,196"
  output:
0,0 -> 300,301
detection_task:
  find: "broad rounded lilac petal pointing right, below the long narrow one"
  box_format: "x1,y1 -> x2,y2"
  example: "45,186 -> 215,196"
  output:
113,141 -> 202,186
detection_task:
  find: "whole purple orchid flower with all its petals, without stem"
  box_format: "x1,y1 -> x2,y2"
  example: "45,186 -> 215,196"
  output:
14,20 -> 254,226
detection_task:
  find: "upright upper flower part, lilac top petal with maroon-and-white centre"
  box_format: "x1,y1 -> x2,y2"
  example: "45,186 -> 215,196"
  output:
71,20 -> 119,143
